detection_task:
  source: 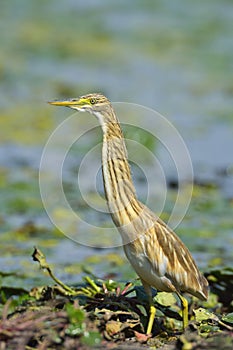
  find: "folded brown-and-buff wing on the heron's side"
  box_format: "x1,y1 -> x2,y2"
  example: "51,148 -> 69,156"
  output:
145,213 -> 208,300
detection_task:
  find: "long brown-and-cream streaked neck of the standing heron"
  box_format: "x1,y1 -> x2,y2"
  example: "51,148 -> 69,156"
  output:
101,108 -> 142,227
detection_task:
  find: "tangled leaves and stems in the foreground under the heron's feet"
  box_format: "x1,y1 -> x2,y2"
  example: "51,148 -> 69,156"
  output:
0,248 -> 233,350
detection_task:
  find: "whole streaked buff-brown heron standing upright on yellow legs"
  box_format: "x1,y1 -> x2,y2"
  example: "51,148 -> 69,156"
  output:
50,94 -> 208,333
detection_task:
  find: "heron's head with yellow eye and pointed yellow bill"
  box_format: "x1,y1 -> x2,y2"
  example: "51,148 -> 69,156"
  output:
48,93 -> 110,115
